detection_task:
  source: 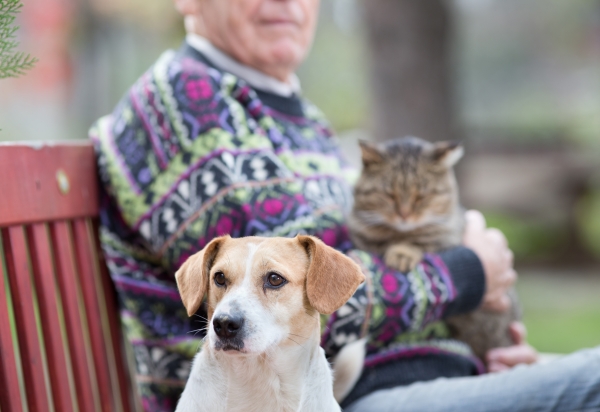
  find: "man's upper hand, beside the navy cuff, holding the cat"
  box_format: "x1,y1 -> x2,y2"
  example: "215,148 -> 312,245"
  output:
463,210 -> 517,312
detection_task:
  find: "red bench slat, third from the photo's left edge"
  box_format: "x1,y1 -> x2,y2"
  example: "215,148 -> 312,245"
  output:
27,224 -> 74,412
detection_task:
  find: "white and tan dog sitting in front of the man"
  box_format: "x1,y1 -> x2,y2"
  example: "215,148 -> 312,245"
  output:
175,235 -> 365,412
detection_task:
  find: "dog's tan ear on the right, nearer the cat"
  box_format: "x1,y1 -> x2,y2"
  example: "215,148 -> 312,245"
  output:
297,235 -> 365,315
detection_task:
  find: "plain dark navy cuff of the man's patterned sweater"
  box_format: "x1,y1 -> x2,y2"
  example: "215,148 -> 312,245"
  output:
439,246 -> 485,317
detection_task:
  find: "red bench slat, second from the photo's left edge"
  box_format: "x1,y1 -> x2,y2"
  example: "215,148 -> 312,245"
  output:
2,226 -> 50,412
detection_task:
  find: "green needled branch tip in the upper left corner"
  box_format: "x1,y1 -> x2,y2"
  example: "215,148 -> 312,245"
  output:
0,0 -> 37,79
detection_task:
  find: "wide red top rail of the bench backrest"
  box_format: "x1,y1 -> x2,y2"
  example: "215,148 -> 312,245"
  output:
0,142 -> 99,226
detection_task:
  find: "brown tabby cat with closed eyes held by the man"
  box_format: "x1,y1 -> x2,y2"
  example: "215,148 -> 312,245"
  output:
348,137 -> 520,359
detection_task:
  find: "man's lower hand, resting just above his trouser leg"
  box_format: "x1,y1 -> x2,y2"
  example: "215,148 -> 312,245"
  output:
486,322 -> 538,373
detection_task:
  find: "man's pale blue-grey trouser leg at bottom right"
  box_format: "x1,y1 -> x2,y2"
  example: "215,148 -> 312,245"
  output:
344,347 -> 600,412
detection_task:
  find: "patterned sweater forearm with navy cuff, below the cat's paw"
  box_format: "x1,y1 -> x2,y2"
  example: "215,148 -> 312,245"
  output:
322,247 -> 485,356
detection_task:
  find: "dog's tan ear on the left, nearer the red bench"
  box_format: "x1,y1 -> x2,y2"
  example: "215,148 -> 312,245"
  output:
175,236 -> 229,316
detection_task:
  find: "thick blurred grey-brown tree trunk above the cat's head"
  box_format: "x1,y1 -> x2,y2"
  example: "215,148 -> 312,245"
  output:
363,0 -> 456,140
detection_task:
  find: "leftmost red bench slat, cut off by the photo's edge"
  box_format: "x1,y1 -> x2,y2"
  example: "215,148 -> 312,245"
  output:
0,232 -> 23,412
